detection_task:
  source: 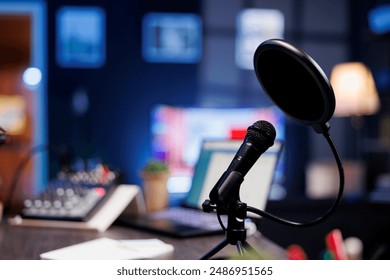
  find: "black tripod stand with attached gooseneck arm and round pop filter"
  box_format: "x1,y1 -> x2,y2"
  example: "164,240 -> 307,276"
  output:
201,39 -> 344,259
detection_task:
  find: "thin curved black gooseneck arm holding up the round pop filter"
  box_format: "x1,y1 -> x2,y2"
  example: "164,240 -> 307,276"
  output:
247,131 -> 344,227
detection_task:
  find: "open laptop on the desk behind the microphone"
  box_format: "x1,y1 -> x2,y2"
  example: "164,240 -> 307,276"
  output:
118,140 -> 282,238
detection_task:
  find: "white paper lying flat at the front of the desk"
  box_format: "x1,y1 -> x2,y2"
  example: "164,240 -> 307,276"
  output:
40,237 -> 174,260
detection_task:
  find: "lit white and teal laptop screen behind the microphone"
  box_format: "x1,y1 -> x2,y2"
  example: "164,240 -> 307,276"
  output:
184,140 -> 282,213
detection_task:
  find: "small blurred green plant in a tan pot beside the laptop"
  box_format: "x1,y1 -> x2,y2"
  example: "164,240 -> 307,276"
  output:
141,159 -> 169,212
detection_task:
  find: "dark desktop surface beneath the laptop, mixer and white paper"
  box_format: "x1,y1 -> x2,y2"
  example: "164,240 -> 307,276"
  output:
0,221 -> 283,260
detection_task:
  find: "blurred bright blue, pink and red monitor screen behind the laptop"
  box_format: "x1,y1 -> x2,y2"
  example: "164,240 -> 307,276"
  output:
151,105 -> 285,195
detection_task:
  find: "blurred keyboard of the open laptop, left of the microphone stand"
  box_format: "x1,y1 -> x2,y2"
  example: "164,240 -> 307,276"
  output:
148,207 -> 227,230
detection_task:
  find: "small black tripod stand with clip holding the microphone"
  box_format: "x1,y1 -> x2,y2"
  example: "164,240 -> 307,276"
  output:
200,172 -> 260,260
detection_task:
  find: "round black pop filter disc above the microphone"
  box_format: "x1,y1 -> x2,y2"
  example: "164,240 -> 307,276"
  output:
254,39 -> 336,133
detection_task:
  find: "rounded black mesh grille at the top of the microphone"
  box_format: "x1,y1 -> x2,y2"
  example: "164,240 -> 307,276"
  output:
246,121 -> 276,149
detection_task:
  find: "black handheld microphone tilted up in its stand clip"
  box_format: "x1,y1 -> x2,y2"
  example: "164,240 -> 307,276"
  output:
209,120 -> 276,212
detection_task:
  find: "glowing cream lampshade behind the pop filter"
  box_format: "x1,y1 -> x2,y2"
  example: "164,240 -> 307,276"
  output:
330,62 -> 380,117
